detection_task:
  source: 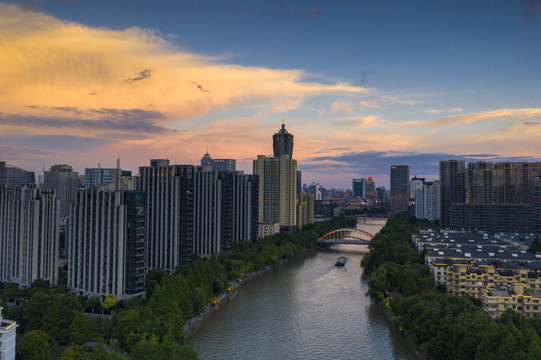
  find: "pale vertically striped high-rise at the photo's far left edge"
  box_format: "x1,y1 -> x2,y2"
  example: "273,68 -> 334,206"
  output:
0,185 -> 59,287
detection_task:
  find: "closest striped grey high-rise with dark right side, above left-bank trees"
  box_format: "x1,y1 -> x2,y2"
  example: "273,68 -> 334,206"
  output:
66,188 -> 146,300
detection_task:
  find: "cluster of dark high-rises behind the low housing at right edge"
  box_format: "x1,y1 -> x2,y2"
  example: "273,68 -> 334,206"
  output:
440,160 -> 541,232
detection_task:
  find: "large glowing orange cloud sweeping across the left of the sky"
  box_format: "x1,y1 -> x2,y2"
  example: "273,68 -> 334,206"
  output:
0,4 -> 367,136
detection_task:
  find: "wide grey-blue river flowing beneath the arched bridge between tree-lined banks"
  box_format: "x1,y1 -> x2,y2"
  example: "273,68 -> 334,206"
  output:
188,225 -> 416,360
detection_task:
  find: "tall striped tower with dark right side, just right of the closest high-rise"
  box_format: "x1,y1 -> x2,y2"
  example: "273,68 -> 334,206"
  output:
139,159 -> 195,272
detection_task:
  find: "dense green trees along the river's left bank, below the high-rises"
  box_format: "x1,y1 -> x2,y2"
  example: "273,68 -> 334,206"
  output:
0,217 -> 356,360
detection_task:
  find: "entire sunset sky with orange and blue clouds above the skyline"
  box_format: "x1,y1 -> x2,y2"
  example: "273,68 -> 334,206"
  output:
0,0 -> 541,188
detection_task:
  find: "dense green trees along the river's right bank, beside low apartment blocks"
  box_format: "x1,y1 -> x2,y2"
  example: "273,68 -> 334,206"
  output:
361,214 -> 541,360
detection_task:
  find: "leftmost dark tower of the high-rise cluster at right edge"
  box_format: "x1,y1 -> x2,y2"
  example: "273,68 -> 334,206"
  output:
440,160 -> 466,227
